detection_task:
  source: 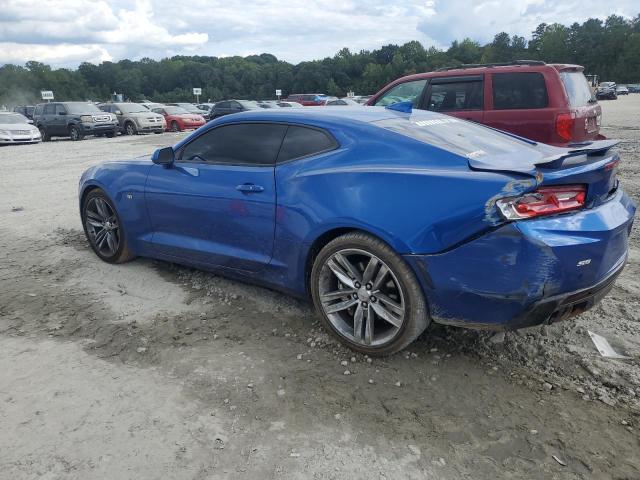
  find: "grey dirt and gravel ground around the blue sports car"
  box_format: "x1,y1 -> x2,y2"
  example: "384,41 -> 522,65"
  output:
0,95 -> 640,479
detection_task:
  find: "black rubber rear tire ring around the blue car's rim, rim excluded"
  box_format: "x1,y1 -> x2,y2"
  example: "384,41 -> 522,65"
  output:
310,233 -> 430,356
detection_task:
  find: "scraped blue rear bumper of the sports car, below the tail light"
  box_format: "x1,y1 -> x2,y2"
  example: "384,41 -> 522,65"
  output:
404,190 -> 635,330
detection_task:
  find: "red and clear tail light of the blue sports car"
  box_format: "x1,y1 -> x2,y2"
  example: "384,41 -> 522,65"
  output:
496,185 -> 587,220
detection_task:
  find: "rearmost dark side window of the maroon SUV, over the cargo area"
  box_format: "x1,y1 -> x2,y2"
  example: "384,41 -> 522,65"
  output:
492,72 -> 549,110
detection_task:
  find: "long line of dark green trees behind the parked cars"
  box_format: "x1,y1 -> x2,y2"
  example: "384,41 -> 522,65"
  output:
0,15 -> 640,106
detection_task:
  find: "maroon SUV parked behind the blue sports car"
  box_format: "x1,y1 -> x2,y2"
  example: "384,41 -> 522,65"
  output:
367,60 -> 603,145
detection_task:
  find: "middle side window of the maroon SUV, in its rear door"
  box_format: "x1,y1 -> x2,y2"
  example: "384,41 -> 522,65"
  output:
427,81 -> 483,112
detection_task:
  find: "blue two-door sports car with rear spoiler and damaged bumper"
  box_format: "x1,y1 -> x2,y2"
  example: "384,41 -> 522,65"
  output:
79,107 -> 635,355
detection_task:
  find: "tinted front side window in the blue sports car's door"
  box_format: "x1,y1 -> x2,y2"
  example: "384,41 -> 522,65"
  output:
180,123 -> 287,166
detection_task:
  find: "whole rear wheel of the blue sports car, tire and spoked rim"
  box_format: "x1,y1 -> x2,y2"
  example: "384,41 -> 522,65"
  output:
310,232 -> 430,356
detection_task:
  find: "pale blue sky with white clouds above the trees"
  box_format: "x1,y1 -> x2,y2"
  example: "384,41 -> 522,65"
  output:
0,0 -> 640,68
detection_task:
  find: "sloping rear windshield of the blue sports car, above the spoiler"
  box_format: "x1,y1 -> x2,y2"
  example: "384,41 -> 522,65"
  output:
375,115 -> 527,158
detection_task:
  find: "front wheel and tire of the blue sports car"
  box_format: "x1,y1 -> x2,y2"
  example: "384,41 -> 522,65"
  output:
80,189 -> 133,263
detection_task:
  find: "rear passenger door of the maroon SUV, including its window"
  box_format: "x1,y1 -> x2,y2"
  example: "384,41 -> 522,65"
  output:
420,75 -> 484,123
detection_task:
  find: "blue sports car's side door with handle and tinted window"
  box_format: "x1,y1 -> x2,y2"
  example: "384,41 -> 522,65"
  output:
145,123 -> 286,272
